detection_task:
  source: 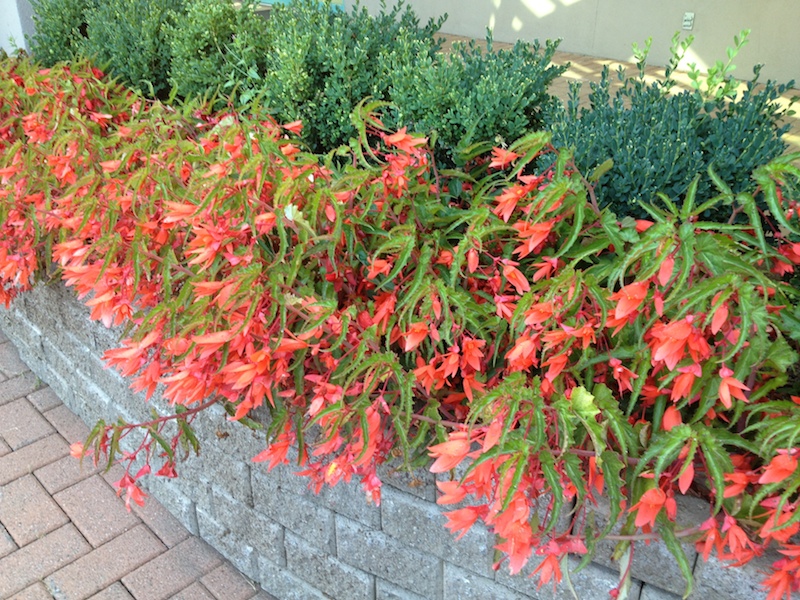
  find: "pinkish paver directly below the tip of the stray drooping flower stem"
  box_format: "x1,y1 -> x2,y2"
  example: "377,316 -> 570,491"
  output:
53,475 -> 140,548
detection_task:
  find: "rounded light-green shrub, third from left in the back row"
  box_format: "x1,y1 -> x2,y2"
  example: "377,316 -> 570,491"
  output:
168,0 -> 269,103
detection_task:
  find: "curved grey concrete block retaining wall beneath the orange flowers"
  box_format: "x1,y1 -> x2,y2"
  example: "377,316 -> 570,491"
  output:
0,283 -> 771,600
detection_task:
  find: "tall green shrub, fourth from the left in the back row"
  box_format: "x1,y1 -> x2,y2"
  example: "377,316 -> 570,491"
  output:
262,0 -> 444,151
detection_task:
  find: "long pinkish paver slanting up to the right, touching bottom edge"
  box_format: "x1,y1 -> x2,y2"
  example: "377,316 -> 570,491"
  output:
45,525 -> 165,600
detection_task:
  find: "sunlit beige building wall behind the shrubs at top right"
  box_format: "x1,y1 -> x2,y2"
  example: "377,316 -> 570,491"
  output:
362,0 -> 800,82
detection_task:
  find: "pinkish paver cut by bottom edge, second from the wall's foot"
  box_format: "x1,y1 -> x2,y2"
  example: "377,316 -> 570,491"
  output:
122,537 -> 222,600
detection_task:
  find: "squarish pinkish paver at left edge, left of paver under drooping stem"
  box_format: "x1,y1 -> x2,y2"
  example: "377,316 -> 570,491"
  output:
0,475 -> 69,546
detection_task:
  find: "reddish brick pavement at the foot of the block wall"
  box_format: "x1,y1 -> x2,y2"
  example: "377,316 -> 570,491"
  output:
0,333 -> 274,600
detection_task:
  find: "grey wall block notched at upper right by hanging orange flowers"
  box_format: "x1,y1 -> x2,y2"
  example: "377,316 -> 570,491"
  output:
381,487 -> 494,579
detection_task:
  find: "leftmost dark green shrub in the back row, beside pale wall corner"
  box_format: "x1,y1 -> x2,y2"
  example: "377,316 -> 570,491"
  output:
29,0 -> 94,67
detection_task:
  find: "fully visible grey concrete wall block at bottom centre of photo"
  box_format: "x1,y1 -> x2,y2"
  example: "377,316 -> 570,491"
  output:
336,515 -> 442,600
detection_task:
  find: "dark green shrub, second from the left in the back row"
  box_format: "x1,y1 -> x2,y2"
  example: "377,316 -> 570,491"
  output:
86,0 -> 184,97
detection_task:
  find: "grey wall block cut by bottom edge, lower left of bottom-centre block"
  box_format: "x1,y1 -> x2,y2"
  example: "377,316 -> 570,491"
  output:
285,532 -> 375,600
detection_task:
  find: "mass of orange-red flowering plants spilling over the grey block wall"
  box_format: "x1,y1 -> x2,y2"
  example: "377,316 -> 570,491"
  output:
7,59 -> 800,598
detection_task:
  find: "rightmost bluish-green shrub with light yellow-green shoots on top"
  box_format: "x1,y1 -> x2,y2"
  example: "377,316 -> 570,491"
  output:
547,32 -> 793,219
